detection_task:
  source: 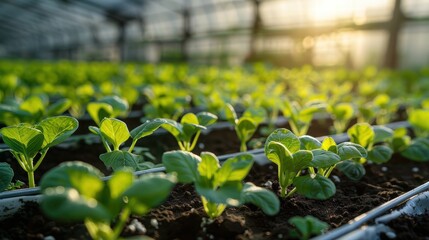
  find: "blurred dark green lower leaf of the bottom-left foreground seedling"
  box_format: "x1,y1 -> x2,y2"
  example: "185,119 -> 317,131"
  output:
41,186 -> 112,222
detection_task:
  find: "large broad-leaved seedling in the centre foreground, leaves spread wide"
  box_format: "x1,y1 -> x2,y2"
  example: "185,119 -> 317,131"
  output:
162,151 -> 280,218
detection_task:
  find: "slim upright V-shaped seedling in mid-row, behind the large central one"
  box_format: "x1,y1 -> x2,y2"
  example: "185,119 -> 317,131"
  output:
225,103 -> 267,152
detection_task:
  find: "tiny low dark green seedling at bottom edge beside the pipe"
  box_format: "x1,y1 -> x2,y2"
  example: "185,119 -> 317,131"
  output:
288,215 -> 329,240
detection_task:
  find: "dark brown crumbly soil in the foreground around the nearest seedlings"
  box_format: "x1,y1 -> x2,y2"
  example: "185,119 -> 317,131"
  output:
0,156 -> 429,239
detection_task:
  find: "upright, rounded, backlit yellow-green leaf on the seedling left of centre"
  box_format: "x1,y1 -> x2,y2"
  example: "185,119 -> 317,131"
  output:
100,118 -> 130,150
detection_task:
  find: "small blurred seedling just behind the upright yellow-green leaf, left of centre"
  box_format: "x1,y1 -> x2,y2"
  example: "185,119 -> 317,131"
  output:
87,96 -> 129,126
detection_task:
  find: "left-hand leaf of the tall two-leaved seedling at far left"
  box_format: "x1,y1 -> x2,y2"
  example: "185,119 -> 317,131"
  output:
1,125 -> 43,159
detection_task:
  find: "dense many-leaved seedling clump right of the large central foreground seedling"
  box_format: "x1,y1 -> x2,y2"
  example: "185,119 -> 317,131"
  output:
265,129 -> 366,199
